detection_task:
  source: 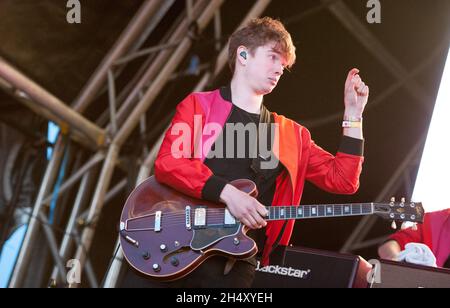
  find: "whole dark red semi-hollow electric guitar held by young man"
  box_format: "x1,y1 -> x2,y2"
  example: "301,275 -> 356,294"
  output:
120,177 -> 424,281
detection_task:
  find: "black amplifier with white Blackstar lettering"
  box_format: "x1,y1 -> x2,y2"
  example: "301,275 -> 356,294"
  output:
253,247 -> 360,288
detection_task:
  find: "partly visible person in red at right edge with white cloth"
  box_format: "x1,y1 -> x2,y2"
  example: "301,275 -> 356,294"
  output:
378,208 -> 450,268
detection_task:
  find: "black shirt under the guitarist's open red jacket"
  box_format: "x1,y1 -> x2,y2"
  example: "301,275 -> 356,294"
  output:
202,87 -> 284,253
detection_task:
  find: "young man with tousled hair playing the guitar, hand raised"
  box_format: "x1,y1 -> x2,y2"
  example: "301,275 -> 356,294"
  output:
120,17 -> 369,287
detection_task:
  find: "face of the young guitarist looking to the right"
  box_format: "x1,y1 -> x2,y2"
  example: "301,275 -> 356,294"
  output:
245,43 -> 286,95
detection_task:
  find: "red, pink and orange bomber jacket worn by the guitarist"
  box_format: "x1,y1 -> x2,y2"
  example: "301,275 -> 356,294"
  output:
154,90 -> 364,264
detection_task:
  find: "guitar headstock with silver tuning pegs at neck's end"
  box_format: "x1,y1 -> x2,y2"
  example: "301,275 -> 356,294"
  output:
374,198 -> 425,228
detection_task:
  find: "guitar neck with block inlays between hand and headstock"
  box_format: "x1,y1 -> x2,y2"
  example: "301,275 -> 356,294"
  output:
266,203 -> 374,221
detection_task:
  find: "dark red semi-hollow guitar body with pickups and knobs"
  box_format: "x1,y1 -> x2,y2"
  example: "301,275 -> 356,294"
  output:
120,177 -> 257,281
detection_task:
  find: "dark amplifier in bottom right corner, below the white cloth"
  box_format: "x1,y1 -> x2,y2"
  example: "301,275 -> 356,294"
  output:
371,260 -> 450,288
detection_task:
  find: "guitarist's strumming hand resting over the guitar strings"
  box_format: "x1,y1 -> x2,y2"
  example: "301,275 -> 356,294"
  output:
220,184 -> 268,229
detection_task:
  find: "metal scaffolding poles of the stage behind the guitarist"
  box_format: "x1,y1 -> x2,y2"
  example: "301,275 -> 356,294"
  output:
0,0 -> 436,288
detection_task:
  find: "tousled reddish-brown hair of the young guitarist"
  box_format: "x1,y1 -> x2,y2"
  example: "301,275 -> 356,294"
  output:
228,17 -> 295,74
